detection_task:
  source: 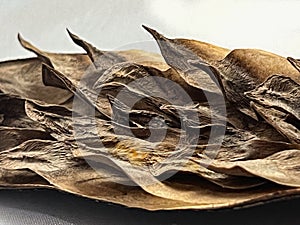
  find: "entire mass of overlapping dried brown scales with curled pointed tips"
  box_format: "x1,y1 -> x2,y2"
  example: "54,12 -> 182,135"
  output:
0,27 -> 300,210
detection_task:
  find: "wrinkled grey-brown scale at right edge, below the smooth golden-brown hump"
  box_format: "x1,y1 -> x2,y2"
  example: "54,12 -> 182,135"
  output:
246,75 -> 300,143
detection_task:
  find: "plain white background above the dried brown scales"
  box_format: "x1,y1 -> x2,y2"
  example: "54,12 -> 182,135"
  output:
0,0 -> 300,60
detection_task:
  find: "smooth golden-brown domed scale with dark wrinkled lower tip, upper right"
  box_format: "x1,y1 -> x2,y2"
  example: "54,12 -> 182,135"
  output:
215,49 -> 300,118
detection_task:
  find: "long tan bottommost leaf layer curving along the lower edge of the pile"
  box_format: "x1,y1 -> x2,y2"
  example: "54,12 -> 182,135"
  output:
0,141 -> 299,210
